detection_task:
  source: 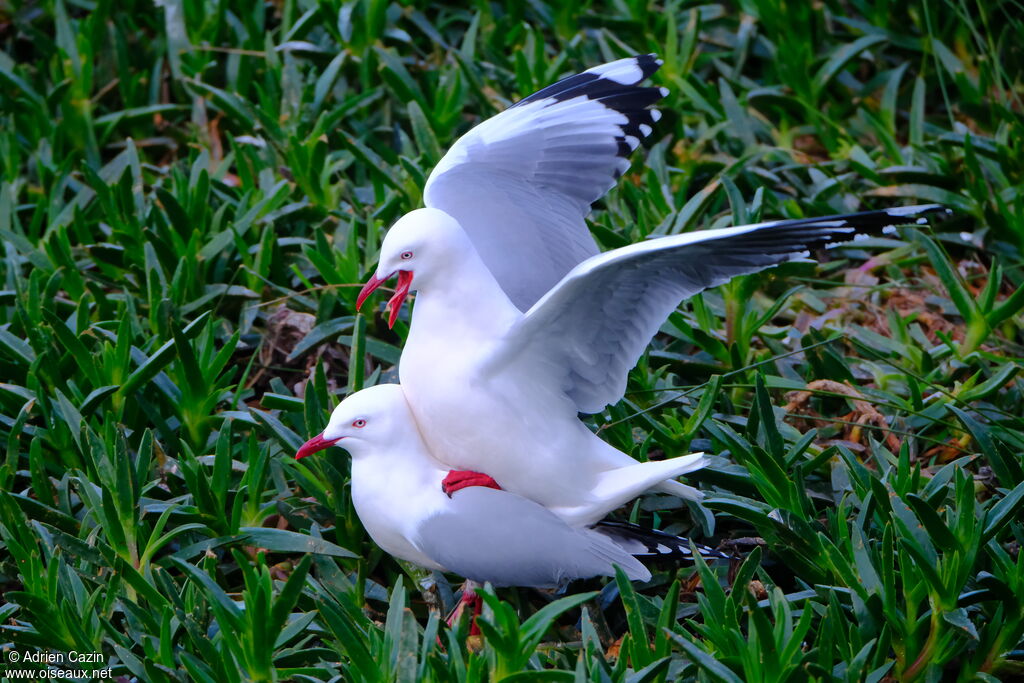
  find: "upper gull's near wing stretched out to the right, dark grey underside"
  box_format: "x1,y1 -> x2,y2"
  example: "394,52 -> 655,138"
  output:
488,205 -> 941,413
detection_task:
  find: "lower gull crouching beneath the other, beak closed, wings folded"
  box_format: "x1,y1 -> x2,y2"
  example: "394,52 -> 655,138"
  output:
300,384 -> 651,588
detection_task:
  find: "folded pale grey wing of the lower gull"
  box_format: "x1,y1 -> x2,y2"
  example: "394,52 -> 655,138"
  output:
415,486 -> 650,588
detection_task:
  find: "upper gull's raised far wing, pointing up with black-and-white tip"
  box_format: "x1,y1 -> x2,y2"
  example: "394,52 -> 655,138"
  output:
423,54 -> 667,310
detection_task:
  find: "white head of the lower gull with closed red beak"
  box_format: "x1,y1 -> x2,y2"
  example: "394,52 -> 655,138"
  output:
295,384 -> 413,459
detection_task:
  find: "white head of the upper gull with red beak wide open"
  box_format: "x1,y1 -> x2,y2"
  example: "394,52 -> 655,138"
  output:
355,209 -> 472,327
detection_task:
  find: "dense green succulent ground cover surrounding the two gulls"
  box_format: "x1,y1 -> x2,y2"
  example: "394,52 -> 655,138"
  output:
0,0 -> 1024,683
